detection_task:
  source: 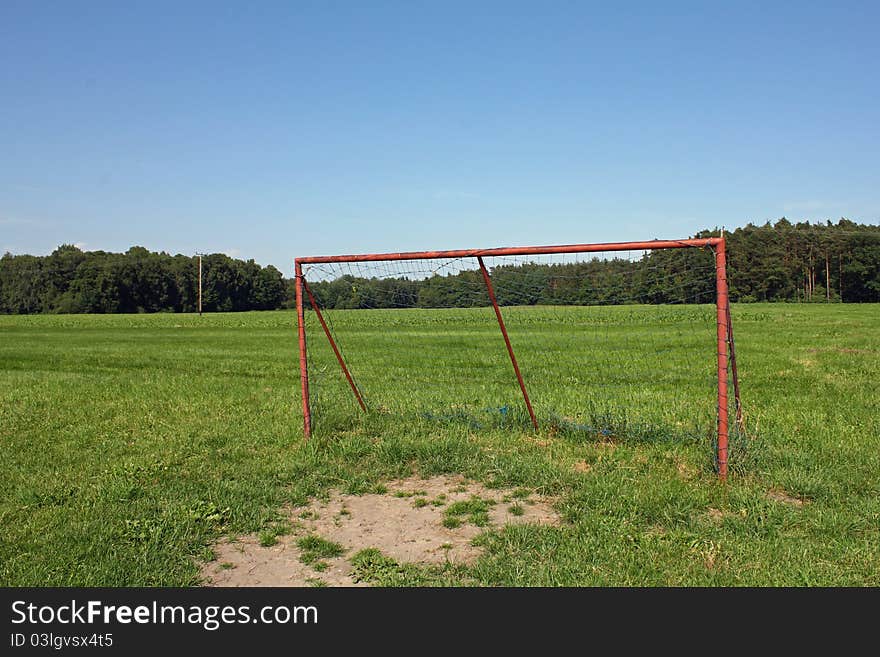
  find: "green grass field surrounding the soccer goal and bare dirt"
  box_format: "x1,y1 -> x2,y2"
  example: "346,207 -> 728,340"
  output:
0,304 -> 880,586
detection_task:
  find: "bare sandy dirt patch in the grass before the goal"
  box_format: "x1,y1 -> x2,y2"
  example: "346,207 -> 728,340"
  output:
202,476 -> 559,586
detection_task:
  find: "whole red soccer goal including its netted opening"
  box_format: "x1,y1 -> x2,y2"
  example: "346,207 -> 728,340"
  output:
295,237 -> 742,479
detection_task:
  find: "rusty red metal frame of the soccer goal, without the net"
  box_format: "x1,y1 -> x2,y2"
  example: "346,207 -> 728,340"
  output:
294,237 -> 742,480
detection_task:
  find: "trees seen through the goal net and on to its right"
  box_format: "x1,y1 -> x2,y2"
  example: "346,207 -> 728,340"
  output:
310,218 -> 880,308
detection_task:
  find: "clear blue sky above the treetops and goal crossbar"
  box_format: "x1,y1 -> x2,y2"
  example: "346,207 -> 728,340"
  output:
0,0 -> 880,275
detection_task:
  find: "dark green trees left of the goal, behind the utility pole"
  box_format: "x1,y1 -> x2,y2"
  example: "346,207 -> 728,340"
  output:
0,244 -> 289,314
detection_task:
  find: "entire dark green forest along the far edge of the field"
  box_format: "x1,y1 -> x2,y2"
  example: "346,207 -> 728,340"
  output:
0,218 -> 880,314
